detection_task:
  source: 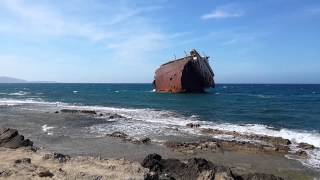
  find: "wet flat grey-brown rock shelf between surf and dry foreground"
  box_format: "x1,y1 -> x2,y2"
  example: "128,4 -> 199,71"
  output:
0,106 -> 320,179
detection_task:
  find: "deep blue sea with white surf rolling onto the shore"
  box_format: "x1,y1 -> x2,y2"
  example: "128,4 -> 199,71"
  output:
0,83 -> 320,169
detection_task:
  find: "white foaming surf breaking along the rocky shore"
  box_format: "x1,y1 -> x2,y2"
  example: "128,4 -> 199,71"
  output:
0,99 -> 320,168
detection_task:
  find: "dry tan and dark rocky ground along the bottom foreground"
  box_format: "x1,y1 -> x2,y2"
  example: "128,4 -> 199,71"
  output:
0,128 -> 290,180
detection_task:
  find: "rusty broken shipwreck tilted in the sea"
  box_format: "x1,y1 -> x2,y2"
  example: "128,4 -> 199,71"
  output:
153,49 -> 215,93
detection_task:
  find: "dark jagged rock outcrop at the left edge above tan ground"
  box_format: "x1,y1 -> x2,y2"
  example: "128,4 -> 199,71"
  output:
0,128 -> 33,149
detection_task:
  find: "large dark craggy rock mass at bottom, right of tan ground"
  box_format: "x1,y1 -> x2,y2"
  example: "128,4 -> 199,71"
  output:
142,154 -> 282,180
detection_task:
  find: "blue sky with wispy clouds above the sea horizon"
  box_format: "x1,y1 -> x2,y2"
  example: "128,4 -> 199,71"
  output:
0,0 -> 320,83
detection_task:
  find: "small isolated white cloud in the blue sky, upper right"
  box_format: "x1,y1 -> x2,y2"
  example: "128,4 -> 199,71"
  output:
201,4 -> 245,19
